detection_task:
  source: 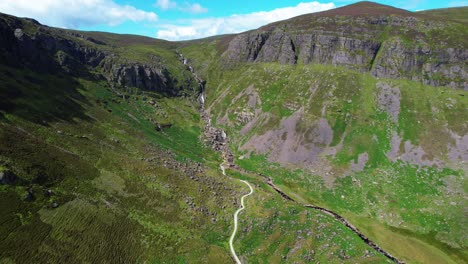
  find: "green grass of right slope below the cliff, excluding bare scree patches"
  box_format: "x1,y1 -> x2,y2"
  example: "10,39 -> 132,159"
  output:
181,35 -> 468,263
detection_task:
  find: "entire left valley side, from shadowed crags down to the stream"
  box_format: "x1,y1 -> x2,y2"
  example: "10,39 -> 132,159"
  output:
0,10 -> 394,263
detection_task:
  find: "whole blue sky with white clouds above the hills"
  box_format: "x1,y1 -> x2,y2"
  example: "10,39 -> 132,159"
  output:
0,0 -> 468,40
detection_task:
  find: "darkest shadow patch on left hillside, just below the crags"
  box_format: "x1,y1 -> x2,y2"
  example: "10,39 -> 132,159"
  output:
0,64 -> 91,125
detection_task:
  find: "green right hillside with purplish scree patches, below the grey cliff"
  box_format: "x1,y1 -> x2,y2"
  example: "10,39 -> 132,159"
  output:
180,9 -> 468,263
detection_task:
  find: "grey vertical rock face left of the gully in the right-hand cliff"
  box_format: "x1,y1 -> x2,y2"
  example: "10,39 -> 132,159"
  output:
225,31 -> 380,71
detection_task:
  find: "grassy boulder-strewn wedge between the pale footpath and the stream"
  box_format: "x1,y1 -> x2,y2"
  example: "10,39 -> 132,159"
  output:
227,170 -> 390,263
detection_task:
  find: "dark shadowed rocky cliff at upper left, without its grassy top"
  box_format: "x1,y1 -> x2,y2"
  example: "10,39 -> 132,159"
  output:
0,15 -> 194,96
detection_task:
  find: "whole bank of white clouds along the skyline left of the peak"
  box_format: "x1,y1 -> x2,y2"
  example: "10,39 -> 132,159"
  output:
0,0 -> 335,40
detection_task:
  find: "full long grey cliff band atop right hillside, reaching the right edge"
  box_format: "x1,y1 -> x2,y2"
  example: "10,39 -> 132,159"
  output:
223,12 -> 468,90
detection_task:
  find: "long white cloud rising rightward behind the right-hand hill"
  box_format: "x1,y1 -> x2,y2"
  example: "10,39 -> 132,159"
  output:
156,2 -> 335,40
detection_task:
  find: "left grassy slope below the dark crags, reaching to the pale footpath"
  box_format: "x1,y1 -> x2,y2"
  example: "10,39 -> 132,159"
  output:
0,62 -> 240,263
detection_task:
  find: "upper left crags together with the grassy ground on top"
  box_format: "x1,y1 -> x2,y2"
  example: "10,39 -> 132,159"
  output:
0,11 -> 198,96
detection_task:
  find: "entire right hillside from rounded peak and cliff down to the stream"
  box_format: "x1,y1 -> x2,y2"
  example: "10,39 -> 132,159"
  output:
179,3 -> 468,263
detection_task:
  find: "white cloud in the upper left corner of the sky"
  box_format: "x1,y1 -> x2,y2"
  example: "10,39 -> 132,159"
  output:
0,0 -> 158,28
